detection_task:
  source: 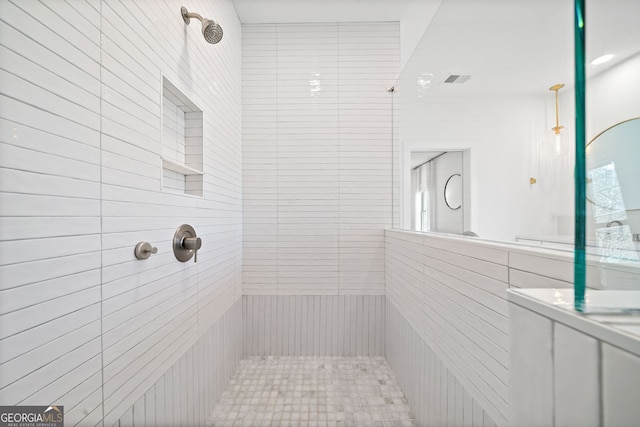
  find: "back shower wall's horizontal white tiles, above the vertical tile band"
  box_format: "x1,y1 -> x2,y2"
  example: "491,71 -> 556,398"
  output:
242,23 -> 400,295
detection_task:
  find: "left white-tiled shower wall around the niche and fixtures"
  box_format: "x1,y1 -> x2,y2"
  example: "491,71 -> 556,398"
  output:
0,0 -> 242,425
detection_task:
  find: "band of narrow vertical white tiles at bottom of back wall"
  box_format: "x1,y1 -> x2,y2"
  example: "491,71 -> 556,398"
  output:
242,295 -> 385,356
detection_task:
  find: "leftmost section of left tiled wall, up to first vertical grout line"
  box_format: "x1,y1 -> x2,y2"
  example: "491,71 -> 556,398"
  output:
0,1 -> 102,425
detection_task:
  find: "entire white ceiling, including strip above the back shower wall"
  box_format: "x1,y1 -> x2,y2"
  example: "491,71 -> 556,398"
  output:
232,0 -> 640,96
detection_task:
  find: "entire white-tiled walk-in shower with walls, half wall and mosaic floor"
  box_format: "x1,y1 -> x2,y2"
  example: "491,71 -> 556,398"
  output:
0,0 -> 640,427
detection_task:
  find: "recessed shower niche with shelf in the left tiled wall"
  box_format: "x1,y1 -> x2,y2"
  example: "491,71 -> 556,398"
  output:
161,76 -> 203,197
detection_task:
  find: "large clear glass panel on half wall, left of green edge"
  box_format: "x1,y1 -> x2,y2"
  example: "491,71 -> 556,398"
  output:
393,0 -> 574,247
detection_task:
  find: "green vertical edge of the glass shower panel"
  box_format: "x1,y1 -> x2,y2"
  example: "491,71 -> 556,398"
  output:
573,0 -> 587,312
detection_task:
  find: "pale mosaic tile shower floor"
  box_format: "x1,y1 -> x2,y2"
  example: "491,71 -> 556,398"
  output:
207,356 -> 418,427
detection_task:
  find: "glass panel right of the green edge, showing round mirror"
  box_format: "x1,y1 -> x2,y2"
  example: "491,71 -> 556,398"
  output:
576,0 -> 640,312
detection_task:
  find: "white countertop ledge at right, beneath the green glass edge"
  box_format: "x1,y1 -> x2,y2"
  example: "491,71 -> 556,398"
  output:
507,288 -> 640,356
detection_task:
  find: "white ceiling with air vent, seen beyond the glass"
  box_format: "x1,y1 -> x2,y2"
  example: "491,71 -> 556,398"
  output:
400,0 -> 640,97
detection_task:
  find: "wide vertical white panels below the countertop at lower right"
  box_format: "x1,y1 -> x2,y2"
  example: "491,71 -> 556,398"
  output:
509,300 -> 640,427
